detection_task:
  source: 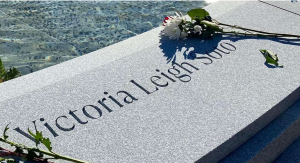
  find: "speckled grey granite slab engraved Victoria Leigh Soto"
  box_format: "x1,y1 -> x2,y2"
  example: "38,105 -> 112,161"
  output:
0,2 -> 300,163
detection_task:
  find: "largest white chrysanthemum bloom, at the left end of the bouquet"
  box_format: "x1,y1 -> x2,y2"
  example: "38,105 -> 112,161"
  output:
162,13 -> 186,40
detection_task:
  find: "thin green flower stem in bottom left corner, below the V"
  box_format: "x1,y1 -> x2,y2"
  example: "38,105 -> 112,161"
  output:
0,137 -> 88,163
